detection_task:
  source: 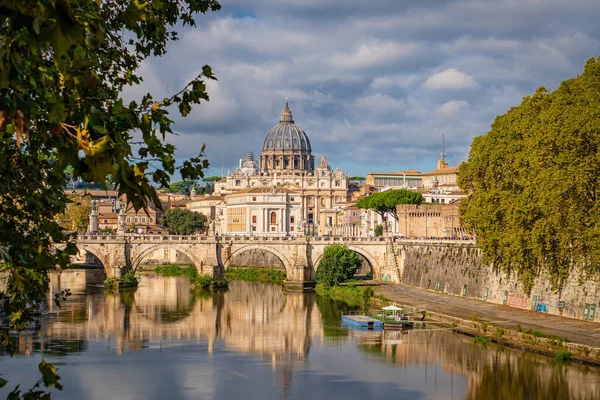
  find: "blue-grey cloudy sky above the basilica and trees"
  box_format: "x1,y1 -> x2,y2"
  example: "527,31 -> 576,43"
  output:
125,0 -> 600,176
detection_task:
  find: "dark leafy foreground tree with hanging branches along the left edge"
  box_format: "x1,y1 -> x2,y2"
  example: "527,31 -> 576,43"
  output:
0,0 -> 220,398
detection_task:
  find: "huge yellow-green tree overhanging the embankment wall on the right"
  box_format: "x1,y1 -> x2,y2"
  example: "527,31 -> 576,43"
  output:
459,58 -> 600,292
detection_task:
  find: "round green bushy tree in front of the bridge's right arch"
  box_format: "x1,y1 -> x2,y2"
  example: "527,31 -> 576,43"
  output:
316,244 -> 361,286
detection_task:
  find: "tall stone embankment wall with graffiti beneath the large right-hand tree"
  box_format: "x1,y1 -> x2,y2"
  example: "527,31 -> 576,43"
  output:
395,243 -> 600,321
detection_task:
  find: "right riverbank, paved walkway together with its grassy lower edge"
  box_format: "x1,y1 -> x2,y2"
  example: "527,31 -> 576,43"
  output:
375,284 -> 600,366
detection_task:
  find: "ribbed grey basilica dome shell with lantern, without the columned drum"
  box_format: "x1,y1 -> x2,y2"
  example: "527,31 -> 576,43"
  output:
263,100 -> 311,152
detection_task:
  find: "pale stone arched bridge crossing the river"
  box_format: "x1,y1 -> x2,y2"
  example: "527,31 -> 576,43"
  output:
77,234 -> 400,282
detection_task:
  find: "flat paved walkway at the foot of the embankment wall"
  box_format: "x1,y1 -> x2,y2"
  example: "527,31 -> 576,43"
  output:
374,284 -> 600,347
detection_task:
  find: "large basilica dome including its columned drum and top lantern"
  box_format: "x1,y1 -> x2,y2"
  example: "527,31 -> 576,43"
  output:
259,99 -> 315,174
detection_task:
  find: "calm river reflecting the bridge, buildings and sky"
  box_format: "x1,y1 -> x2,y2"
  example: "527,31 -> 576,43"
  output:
0,271 -> 600,400
